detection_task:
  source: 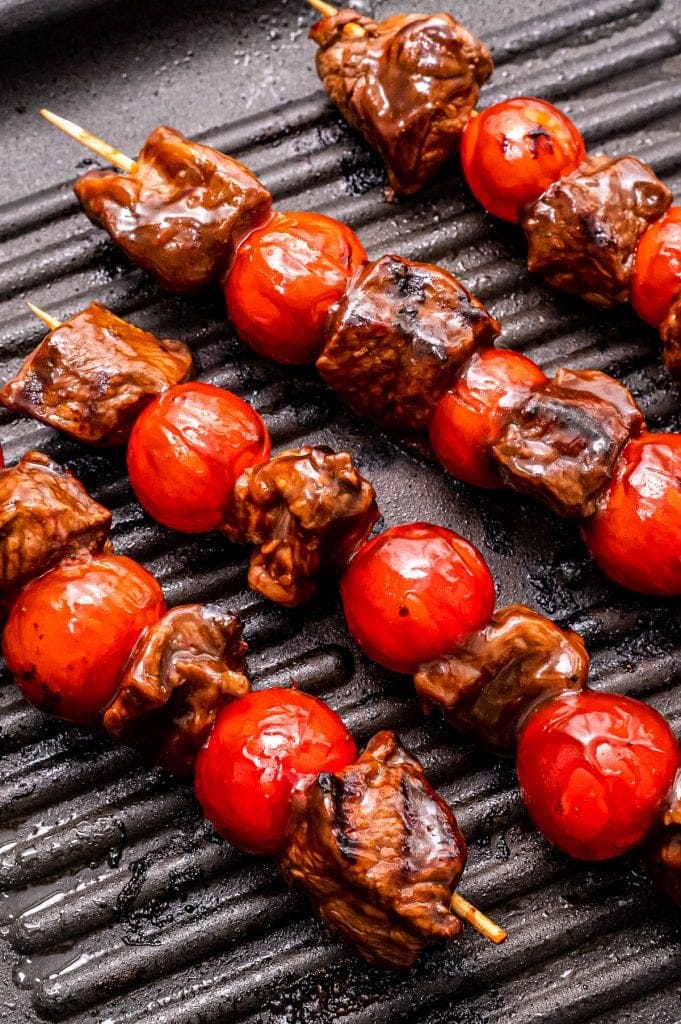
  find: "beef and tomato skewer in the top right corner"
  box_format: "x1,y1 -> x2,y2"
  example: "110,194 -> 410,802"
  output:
308,0 -> 681,377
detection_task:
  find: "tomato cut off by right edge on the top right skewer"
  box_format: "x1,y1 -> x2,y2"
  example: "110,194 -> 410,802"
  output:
631,206 -> 681,327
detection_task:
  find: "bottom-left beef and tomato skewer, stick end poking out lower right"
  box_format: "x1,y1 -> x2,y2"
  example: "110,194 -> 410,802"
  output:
0,452 -> 506,968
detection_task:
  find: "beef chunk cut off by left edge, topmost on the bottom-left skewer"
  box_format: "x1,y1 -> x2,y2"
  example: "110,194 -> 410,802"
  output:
0,452 -> 112,617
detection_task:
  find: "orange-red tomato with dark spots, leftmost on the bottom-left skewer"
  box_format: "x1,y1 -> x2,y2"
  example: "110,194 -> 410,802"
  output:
2,555 -> 166,725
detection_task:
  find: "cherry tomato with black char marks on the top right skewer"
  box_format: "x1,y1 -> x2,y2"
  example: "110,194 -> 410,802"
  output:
461,96 -> 586,223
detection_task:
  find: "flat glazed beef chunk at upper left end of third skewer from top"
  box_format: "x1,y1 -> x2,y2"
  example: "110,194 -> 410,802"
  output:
0,302 -> 193,445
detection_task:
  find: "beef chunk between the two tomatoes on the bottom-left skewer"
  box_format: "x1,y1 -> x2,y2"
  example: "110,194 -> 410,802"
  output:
103,604 -> 249,775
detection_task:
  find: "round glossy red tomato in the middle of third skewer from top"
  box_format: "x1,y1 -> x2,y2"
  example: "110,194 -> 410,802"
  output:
341,522 -> 495,673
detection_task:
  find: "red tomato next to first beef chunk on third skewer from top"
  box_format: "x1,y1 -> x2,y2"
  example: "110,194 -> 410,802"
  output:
128,381 -> 271,534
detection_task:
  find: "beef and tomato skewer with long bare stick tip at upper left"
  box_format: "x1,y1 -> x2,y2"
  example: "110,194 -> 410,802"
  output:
18,112 -> 681,596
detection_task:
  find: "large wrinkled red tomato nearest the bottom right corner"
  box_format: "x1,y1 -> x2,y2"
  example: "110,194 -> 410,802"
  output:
517,690 -> 681,860
